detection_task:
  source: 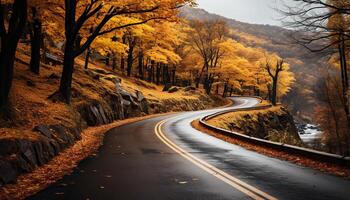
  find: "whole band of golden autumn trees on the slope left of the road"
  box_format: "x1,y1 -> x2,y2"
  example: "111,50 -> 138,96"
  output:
0,0 -> 294,120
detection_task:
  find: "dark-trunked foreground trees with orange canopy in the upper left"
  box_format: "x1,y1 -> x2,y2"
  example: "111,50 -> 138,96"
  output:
0,0 -> 194,117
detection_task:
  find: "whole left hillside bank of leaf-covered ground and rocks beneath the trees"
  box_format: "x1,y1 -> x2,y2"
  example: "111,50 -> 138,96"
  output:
0,43 -> 226,185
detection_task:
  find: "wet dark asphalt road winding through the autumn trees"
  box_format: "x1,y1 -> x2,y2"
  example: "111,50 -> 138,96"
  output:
29,98 -> 350,200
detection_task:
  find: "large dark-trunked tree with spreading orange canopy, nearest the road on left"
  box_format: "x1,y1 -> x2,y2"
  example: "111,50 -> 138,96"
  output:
49,0 -> 193,103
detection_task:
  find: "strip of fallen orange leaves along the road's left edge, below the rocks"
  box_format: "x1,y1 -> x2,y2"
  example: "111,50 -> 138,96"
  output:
0,114 -> 171,200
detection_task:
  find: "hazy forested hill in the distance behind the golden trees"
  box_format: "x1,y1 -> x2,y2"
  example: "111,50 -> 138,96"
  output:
181,7 -> 326,120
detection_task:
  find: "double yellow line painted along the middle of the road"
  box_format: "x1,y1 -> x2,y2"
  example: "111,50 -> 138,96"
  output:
155,120 -> 277,200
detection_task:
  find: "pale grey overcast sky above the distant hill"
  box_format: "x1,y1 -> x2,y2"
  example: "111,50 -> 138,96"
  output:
197,0 -> 281,26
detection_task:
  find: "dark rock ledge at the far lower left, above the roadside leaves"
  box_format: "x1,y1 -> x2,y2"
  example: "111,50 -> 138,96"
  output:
0,125 -> 81,185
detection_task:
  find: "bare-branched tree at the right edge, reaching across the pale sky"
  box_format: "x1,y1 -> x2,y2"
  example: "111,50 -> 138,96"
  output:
281,0 -> 350,127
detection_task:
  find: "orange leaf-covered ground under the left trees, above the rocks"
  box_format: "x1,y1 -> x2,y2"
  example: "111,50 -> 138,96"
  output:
0,44 -> 208,140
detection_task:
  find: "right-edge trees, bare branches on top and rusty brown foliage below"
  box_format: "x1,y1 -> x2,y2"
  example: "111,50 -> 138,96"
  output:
282,0 -> 350,156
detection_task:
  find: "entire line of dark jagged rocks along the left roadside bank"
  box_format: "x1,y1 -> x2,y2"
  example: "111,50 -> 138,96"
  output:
0,70 -> 224,185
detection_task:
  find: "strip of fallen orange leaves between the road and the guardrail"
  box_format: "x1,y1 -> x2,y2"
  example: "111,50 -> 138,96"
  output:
192,121 -> 350,179
